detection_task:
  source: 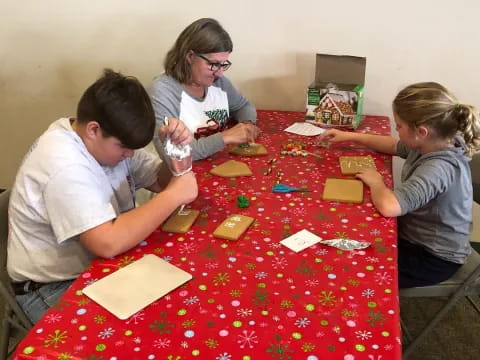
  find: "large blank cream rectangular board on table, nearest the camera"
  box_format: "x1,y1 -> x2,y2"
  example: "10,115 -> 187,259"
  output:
83,254 -> 192,320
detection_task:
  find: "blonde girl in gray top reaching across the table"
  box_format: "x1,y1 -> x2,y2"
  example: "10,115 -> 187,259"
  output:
320,82 -> 480,288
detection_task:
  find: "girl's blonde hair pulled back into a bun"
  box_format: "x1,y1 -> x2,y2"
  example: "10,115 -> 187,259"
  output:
393,82 -> 480,155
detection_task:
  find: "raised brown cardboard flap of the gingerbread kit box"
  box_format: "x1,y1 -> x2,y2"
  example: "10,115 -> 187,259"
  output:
315,54 -> 367,84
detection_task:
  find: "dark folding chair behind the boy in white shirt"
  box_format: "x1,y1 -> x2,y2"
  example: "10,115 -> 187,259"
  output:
0,190 -> 32,360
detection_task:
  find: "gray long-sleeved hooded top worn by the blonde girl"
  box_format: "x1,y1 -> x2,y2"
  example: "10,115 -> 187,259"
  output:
394,136 -> 472,264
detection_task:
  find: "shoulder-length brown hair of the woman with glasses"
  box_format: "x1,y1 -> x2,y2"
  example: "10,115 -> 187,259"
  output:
163,18 -> 233,84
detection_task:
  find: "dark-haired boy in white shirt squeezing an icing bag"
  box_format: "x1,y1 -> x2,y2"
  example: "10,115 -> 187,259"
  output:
7,70 -> 198,323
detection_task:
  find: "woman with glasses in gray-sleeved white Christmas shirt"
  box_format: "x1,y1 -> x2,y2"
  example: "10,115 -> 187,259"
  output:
150,18 -> 259,160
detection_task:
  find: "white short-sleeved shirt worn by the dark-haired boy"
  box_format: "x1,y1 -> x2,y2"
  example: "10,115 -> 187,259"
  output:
7,118 -> 160,282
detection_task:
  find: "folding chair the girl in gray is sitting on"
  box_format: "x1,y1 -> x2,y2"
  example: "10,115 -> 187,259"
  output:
400,153 -> 480,359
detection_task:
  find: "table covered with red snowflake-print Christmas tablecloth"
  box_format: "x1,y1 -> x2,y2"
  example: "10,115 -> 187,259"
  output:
14,111 -> 401,360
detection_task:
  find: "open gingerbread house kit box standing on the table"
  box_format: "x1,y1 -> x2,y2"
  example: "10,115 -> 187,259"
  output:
305,54 -> 367,129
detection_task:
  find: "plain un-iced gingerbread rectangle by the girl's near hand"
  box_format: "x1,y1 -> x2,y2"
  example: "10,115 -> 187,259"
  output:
323,179 -> 363,204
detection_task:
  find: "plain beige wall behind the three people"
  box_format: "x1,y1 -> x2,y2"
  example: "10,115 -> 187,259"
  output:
0,0 -> 480,187
